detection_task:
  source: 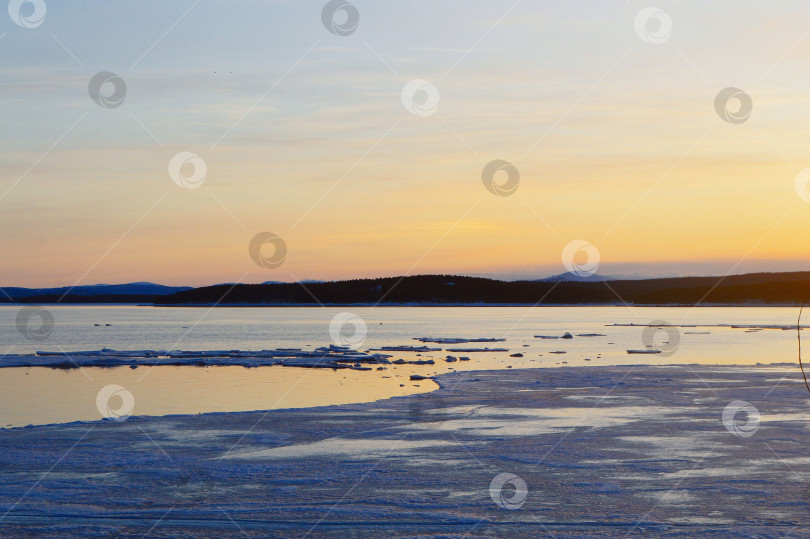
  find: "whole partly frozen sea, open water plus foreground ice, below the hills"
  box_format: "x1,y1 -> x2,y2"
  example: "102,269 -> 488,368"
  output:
0,306 -> 810,538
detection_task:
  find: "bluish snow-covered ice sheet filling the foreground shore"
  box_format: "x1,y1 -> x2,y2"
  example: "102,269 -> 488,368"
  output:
0,365 -> 810,537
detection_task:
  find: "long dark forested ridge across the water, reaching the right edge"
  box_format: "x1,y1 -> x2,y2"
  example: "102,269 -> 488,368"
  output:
155,272 -> 810,305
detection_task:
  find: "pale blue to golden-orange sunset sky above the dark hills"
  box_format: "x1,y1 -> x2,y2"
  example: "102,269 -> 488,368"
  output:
0,0 -> 810,287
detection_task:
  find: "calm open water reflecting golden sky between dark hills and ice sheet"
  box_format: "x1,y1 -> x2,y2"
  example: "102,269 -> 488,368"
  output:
0,306 -> 798,428
